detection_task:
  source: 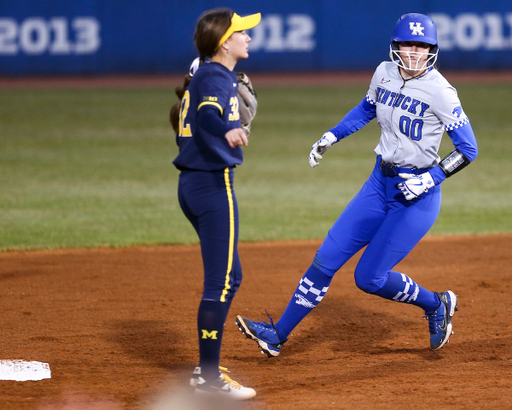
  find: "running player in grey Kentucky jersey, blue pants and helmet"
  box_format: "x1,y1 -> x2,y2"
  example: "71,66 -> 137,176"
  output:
236,13 -> 478,357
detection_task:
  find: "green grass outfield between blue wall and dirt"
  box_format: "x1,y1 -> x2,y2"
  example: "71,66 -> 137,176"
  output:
0,84 -> 512,250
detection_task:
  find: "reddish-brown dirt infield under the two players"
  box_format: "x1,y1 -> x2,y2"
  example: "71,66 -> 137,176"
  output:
0,235 -> 512,410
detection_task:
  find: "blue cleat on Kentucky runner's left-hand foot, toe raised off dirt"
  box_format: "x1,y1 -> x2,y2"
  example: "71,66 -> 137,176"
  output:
235,315 -> 288,357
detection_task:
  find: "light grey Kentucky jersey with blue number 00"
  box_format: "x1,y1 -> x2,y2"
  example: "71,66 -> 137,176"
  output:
366,61 -> 469,168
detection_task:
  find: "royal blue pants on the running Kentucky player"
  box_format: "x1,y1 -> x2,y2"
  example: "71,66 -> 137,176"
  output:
314,156 -> 441,293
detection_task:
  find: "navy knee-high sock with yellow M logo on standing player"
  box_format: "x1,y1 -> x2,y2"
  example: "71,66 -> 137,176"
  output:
197,300 -> 227,380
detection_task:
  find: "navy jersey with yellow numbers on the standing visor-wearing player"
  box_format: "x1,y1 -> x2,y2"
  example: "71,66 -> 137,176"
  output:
173,61 -> 243,171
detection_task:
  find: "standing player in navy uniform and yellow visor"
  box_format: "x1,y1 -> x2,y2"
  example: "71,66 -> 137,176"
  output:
171,9 -> 261,400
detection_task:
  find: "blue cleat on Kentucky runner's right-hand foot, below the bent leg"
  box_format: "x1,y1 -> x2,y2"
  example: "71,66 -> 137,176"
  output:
424,290 -> 458,350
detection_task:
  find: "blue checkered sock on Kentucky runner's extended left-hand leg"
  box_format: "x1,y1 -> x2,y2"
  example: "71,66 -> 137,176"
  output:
275,265 -> 332,340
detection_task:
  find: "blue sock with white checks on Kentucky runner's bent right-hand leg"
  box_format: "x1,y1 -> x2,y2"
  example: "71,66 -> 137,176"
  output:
374,271 -> 439,312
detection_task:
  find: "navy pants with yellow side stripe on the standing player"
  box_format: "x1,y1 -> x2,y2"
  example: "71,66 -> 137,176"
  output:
178,168 -> 242,302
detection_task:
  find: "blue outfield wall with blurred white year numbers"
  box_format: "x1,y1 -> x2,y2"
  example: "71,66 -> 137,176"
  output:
0,0 -> 512,76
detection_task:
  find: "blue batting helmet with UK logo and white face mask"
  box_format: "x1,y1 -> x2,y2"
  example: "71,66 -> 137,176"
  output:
389,13 -> 439,71
